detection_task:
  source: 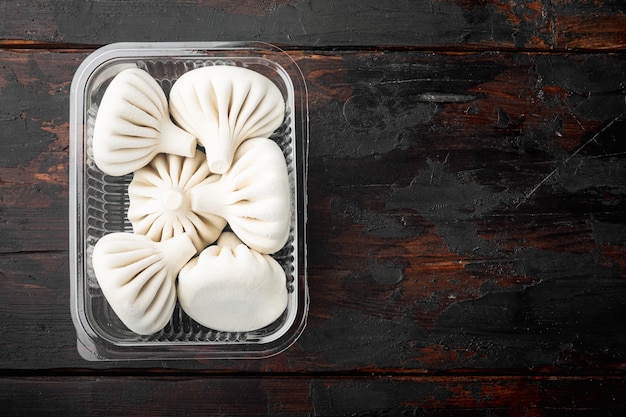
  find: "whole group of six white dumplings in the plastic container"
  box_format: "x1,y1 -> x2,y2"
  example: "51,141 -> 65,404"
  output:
93,66 -> 291,335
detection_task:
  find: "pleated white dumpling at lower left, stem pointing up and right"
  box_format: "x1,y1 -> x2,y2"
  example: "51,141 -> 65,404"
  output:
92,232 -> 196,335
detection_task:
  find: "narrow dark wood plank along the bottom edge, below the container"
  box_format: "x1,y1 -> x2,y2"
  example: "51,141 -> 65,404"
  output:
0,376 -> 626,417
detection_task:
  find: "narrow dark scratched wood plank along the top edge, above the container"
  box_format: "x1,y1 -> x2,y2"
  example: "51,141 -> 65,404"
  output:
0,0 -> 626,50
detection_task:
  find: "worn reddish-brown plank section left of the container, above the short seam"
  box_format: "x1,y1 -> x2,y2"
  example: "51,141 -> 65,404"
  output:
0,48 -> 77,253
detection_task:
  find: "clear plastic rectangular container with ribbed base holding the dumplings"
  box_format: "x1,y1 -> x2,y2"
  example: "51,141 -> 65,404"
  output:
69,42 -> 309,361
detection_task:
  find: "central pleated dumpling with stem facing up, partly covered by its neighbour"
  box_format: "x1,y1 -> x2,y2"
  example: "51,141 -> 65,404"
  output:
128,152 -> 226,251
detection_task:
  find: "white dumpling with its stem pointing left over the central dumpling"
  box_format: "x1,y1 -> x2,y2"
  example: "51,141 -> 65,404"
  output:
191,138 -> 291,254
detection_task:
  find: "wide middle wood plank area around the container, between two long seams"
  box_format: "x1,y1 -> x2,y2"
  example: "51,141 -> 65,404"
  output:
0,50 -> 626,374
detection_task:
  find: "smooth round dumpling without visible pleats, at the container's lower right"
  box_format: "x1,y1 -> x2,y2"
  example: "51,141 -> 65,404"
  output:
177,232 -> 288,332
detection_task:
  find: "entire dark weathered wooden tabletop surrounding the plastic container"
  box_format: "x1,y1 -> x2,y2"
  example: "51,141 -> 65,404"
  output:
0,0 -> 626,416
